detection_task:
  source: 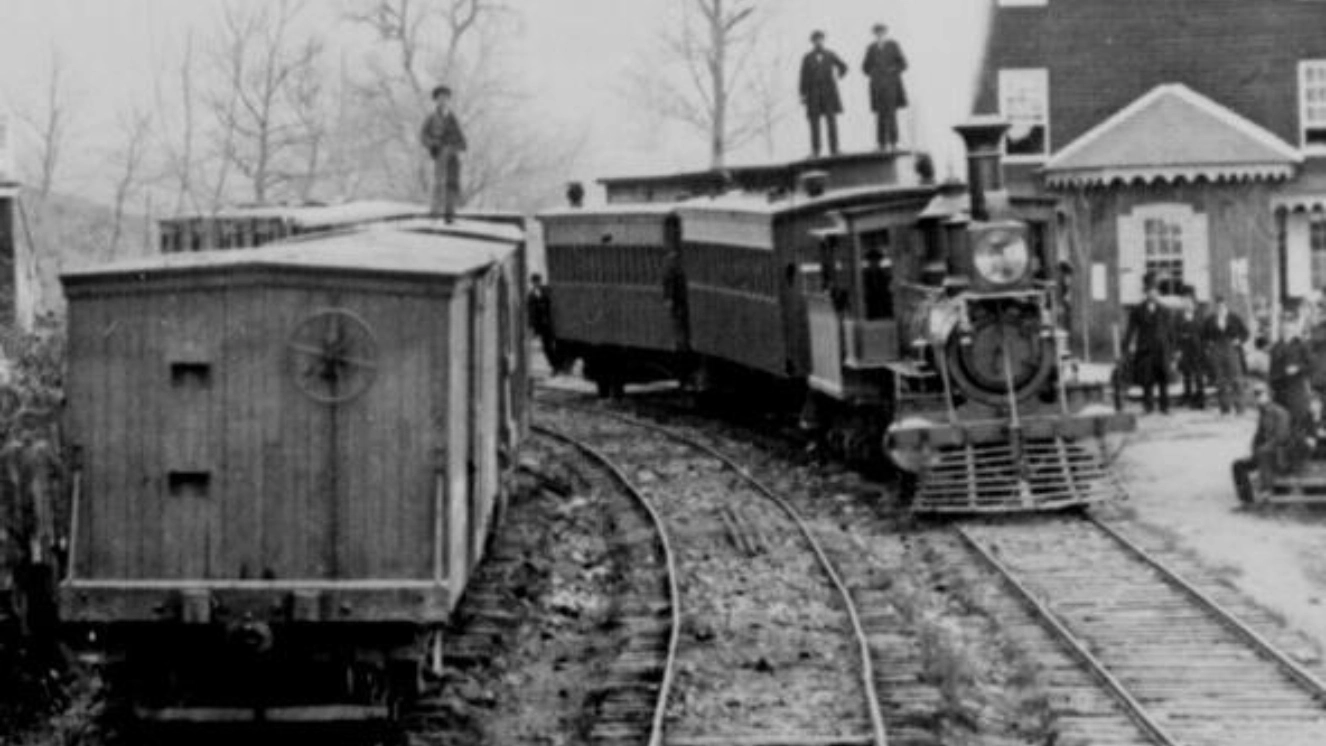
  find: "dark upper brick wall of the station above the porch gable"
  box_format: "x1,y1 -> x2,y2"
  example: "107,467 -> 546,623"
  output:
975,0 -> 1326,151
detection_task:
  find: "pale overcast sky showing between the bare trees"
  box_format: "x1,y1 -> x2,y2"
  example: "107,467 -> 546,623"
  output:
0,0 -> 993,204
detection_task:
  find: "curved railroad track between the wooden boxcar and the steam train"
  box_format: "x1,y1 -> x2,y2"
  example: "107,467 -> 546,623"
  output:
540,396 -> 886,746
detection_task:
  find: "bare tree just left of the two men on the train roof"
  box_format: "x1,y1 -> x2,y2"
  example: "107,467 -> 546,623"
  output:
629,0 -> 781,168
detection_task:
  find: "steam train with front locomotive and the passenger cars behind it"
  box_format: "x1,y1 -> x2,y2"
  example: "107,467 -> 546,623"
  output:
540,119 -> 1135,513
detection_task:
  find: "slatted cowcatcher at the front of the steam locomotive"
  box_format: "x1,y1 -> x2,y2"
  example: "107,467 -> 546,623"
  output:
912,437 -> 1126,514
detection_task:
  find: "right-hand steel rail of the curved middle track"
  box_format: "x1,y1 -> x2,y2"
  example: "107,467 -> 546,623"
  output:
538,401 -> 888,746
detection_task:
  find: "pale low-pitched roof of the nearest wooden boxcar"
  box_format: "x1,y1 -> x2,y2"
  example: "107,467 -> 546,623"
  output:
61,221 -> 521,284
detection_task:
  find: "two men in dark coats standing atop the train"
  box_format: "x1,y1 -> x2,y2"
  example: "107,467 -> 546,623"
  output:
800,24 -> 907,156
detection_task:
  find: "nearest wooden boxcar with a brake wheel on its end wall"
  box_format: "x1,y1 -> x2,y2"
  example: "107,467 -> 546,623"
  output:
60,221 -> 524,721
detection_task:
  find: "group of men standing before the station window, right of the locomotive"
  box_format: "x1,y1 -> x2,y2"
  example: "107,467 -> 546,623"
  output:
1123,282 -> 1249,415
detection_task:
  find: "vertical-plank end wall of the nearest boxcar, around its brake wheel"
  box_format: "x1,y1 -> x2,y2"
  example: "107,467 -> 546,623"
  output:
69,281 -> 461,579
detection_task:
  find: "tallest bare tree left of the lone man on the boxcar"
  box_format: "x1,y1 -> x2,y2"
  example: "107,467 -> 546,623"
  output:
207,0 -> 325,203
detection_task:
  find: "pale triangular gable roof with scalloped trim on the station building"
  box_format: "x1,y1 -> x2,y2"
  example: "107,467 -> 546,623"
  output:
1045,83 -> 1303,186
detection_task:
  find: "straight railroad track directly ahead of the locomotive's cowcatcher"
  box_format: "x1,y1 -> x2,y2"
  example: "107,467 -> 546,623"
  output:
956,517 -> 1326,746
